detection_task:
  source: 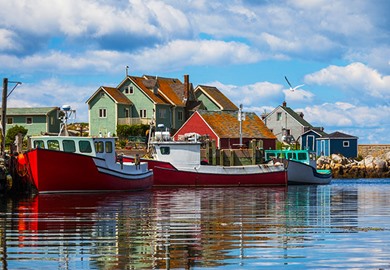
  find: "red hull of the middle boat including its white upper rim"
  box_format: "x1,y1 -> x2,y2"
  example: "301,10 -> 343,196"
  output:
153,165 -> 287,187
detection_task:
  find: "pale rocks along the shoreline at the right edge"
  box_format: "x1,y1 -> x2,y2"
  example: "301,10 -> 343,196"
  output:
317,152 -> 390,178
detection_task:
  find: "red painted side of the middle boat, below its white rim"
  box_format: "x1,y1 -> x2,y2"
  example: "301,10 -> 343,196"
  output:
153,166 -> 287,186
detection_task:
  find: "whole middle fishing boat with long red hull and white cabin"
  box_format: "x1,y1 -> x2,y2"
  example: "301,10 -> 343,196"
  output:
124,132 -> 287,187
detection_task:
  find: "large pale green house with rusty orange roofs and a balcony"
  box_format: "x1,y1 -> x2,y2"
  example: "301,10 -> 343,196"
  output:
86,75 -> 199,136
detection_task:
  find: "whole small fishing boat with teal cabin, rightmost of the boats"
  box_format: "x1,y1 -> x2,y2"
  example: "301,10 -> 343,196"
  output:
265,149 -> 332,185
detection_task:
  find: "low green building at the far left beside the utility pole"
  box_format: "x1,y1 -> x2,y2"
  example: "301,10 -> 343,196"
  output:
1,107 -> 60,135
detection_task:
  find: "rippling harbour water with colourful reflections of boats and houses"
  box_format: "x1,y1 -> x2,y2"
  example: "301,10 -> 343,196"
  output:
0,179 -> 390,269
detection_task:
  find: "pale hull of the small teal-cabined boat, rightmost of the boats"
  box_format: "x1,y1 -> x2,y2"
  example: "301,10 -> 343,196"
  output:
287,160 -> 332,185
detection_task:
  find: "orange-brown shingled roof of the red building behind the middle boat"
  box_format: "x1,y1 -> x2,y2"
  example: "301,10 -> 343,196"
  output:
198,110 -> 276,139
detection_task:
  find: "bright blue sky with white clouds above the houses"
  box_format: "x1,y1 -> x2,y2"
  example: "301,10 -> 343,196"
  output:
0,0 -> 390,144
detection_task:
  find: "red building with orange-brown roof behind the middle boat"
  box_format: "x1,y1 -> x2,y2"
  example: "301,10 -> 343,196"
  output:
173,110 -> 276,149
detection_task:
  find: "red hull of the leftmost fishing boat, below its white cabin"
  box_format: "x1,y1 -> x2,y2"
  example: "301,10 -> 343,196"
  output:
26,149 -> 153,192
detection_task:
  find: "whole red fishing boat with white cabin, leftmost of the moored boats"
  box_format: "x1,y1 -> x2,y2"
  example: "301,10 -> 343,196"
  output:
17,105 -> 153,193
